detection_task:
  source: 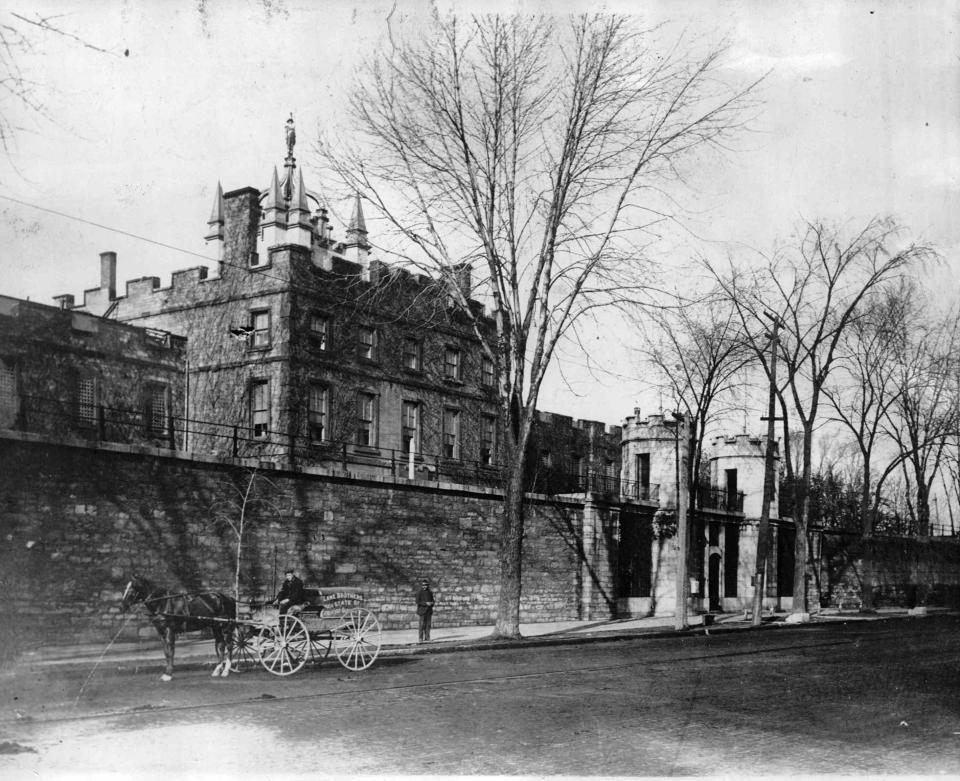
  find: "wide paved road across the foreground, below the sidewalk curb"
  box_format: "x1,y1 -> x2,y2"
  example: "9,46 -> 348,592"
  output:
0,616 -> 960,779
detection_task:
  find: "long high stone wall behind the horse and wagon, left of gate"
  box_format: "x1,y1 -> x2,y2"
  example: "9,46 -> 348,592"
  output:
0,432 -> 592,642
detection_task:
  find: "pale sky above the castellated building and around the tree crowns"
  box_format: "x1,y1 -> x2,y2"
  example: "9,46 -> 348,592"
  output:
0,0 -> 960,427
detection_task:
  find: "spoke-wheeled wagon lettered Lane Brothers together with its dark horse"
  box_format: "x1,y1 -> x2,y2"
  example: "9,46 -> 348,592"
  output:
122,577 -> 381,680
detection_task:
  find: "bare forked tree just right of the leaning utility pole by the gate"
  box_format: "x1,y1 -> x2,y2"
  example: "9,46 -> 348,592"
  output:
710,219 -> 934,612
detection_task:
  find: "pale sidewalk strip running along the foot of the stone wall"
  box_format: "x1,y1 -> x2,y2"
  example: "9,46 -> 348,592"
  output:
12,608 -> 936,672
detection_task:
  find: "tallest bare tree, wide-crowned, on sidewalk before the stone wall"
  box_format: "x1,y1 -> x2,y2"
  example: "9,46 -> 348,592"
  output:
320,15 -> 752,638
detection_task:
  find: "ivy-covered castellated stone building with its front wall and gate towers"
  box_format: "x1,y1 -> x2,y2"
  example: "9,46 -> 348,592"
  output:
0,123 -> 952,639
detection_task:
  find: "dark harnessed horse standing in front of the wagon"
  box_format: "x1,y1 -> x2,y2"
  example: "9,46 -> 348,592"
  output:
120,575 -> 237,681
